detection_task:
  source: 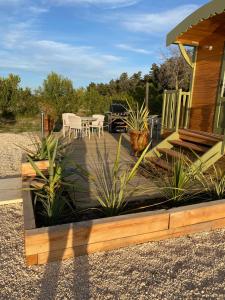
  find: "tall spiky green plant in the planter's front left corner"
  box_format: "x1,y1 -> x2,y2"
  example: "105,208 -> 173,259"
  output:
28,141 -> 77,225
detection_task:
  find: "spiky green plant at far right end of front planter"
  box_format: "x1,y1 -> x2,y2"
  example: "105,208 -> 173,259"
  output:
197,165 -> 225,200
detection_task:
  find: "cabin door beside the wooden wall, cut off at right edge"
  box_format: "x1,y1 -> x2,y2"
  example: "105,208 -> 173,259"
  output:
214,46 -> 225,134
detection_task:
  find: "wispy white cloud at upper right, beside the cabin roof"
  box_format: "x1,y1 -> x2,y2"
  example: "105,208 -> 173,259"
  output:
122,4 -> 198,34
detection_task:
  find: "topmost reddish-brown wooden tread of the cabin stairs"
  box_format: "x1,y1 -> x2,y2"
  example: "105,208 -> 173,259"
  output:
179,129 -> 221,145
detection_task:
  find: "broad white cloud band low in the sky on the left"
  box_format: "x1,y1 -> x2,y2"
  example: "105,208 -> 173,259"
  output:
0,22 -> 122,82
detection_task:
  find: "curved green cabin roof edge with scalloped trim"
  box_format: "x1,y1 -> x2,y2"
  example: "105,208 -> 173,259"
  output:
166,0 -> 225,46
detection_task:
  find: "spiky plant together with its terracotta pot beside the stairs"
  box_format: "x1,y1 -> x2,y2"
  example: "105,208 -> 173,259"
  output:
125,101 -> 149,156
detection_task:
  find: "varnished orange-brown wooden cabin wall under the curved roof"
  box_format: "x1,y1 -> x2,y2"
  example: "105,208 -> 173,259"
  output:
190,34 -> 225,132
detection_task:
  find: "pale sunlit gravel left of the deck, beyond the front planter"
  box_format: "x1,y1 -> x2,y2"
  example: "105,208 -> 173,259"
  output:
0,133 -> 36,178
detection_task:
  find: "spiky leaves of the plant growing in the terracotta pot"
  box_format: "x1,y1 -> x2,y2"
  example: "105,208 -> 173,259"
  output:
125,101 -> 149,132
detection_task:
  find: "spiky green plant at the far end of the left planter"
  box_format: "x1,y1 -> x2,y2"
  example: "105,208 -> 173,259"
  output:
19,133 -> 67,161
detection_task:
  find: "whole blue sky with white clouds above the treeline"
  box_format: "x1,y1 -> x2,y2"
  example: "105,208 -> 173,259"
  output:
0,0 -> 208,88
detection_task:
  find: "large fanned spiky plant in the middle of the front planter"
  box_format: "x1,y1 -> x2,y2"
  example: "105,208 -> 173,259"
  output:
90,136 -> 149,216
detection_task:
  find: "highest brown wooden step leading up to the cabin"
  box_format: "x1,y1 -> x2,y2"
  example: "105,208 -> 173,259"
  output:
178,129 -> 218,146
